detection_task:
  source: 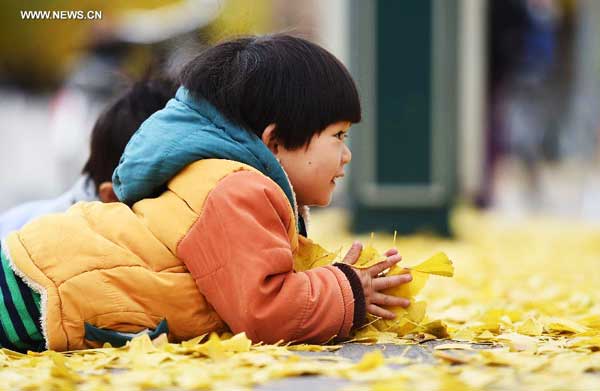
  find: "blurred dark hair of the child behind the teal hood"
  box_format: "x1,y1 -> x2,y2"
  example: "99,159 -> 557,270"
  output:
83,79 -> 176,189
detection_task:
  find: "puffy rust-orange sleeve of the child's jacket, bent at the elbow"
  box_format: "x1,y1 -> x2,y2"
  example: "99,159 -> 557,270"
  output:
177,171 -> 364,343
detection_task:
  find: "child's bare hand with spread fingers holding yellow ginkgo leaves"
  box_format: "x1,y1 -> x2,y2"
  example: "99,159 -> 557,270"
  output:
343,242 -> 412,319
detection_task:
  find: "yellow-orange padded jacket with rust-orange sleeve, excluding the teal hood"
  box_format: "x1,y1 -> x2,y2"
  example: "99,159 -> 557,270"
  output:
3,159 -> 355,350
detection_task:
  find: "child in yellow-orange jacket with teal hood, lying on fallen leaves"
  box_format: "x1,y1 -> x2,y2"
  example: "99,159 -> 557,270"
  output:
2,35 -> 410,350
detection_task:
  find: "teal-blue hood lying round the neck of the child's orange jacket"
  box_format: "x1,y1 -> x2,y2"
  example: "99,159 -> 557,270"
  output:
113,87 -> 306,235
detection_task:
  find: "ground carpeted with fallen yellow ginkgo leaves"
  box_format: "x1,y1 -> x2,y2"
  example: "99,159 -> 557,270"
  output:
0,209 -> 600,390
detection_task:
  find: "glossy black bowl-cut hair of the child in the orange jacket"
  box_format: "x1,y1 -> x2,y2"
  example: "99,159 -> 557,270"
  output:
180,34 -> 361,149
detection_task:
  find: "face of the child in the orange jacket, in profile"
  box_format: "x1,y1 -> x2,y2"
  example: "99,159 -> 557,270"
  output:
275,122 -> 352,206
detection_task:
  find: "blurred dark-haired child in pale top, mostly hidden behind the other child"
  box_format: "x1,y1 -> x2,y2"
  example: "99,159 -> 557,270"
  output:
0,80 -> 175,238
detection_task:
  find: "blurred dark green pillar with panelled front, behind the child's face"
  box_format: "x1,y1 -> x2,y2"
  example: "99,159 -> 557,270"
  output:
350,0 -> 459,234
